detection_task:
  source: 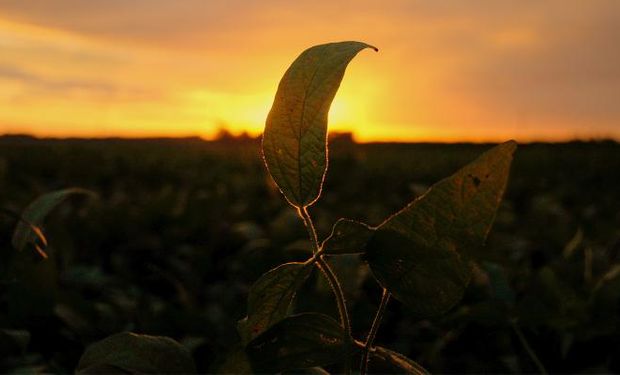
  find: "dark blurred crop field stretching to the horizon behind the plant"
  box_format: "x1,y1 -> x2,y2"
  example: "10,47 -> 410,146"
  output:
0,137 -> 620,373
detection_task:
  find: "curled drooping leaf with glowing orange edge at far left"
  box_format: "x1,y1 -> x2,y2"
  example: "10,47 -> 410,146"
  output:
12,188 -> 93,251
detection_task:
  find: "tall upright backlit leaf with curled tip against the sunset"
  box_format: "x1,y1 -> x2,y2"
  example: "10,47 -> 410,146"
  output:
263,42 -> 377,207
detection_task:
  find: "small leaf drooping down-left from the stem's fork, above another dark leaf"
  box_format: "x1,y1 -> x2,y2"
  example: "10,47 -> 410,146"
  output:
238,263 -> 313,343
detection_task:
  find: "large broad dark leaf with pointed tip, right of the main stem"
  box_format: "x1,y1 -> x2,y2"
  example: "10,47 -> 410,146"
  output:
366,141 -> 516,317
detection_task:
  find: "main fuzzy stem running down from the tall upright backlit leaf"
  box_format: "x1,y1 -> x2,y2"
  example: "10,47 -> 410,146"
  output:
297,207 -> 353,374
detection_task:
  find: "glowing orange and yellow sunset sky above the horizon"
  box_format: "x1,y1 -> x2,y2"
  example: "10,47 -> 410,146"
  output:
0,0 -> 620,142
